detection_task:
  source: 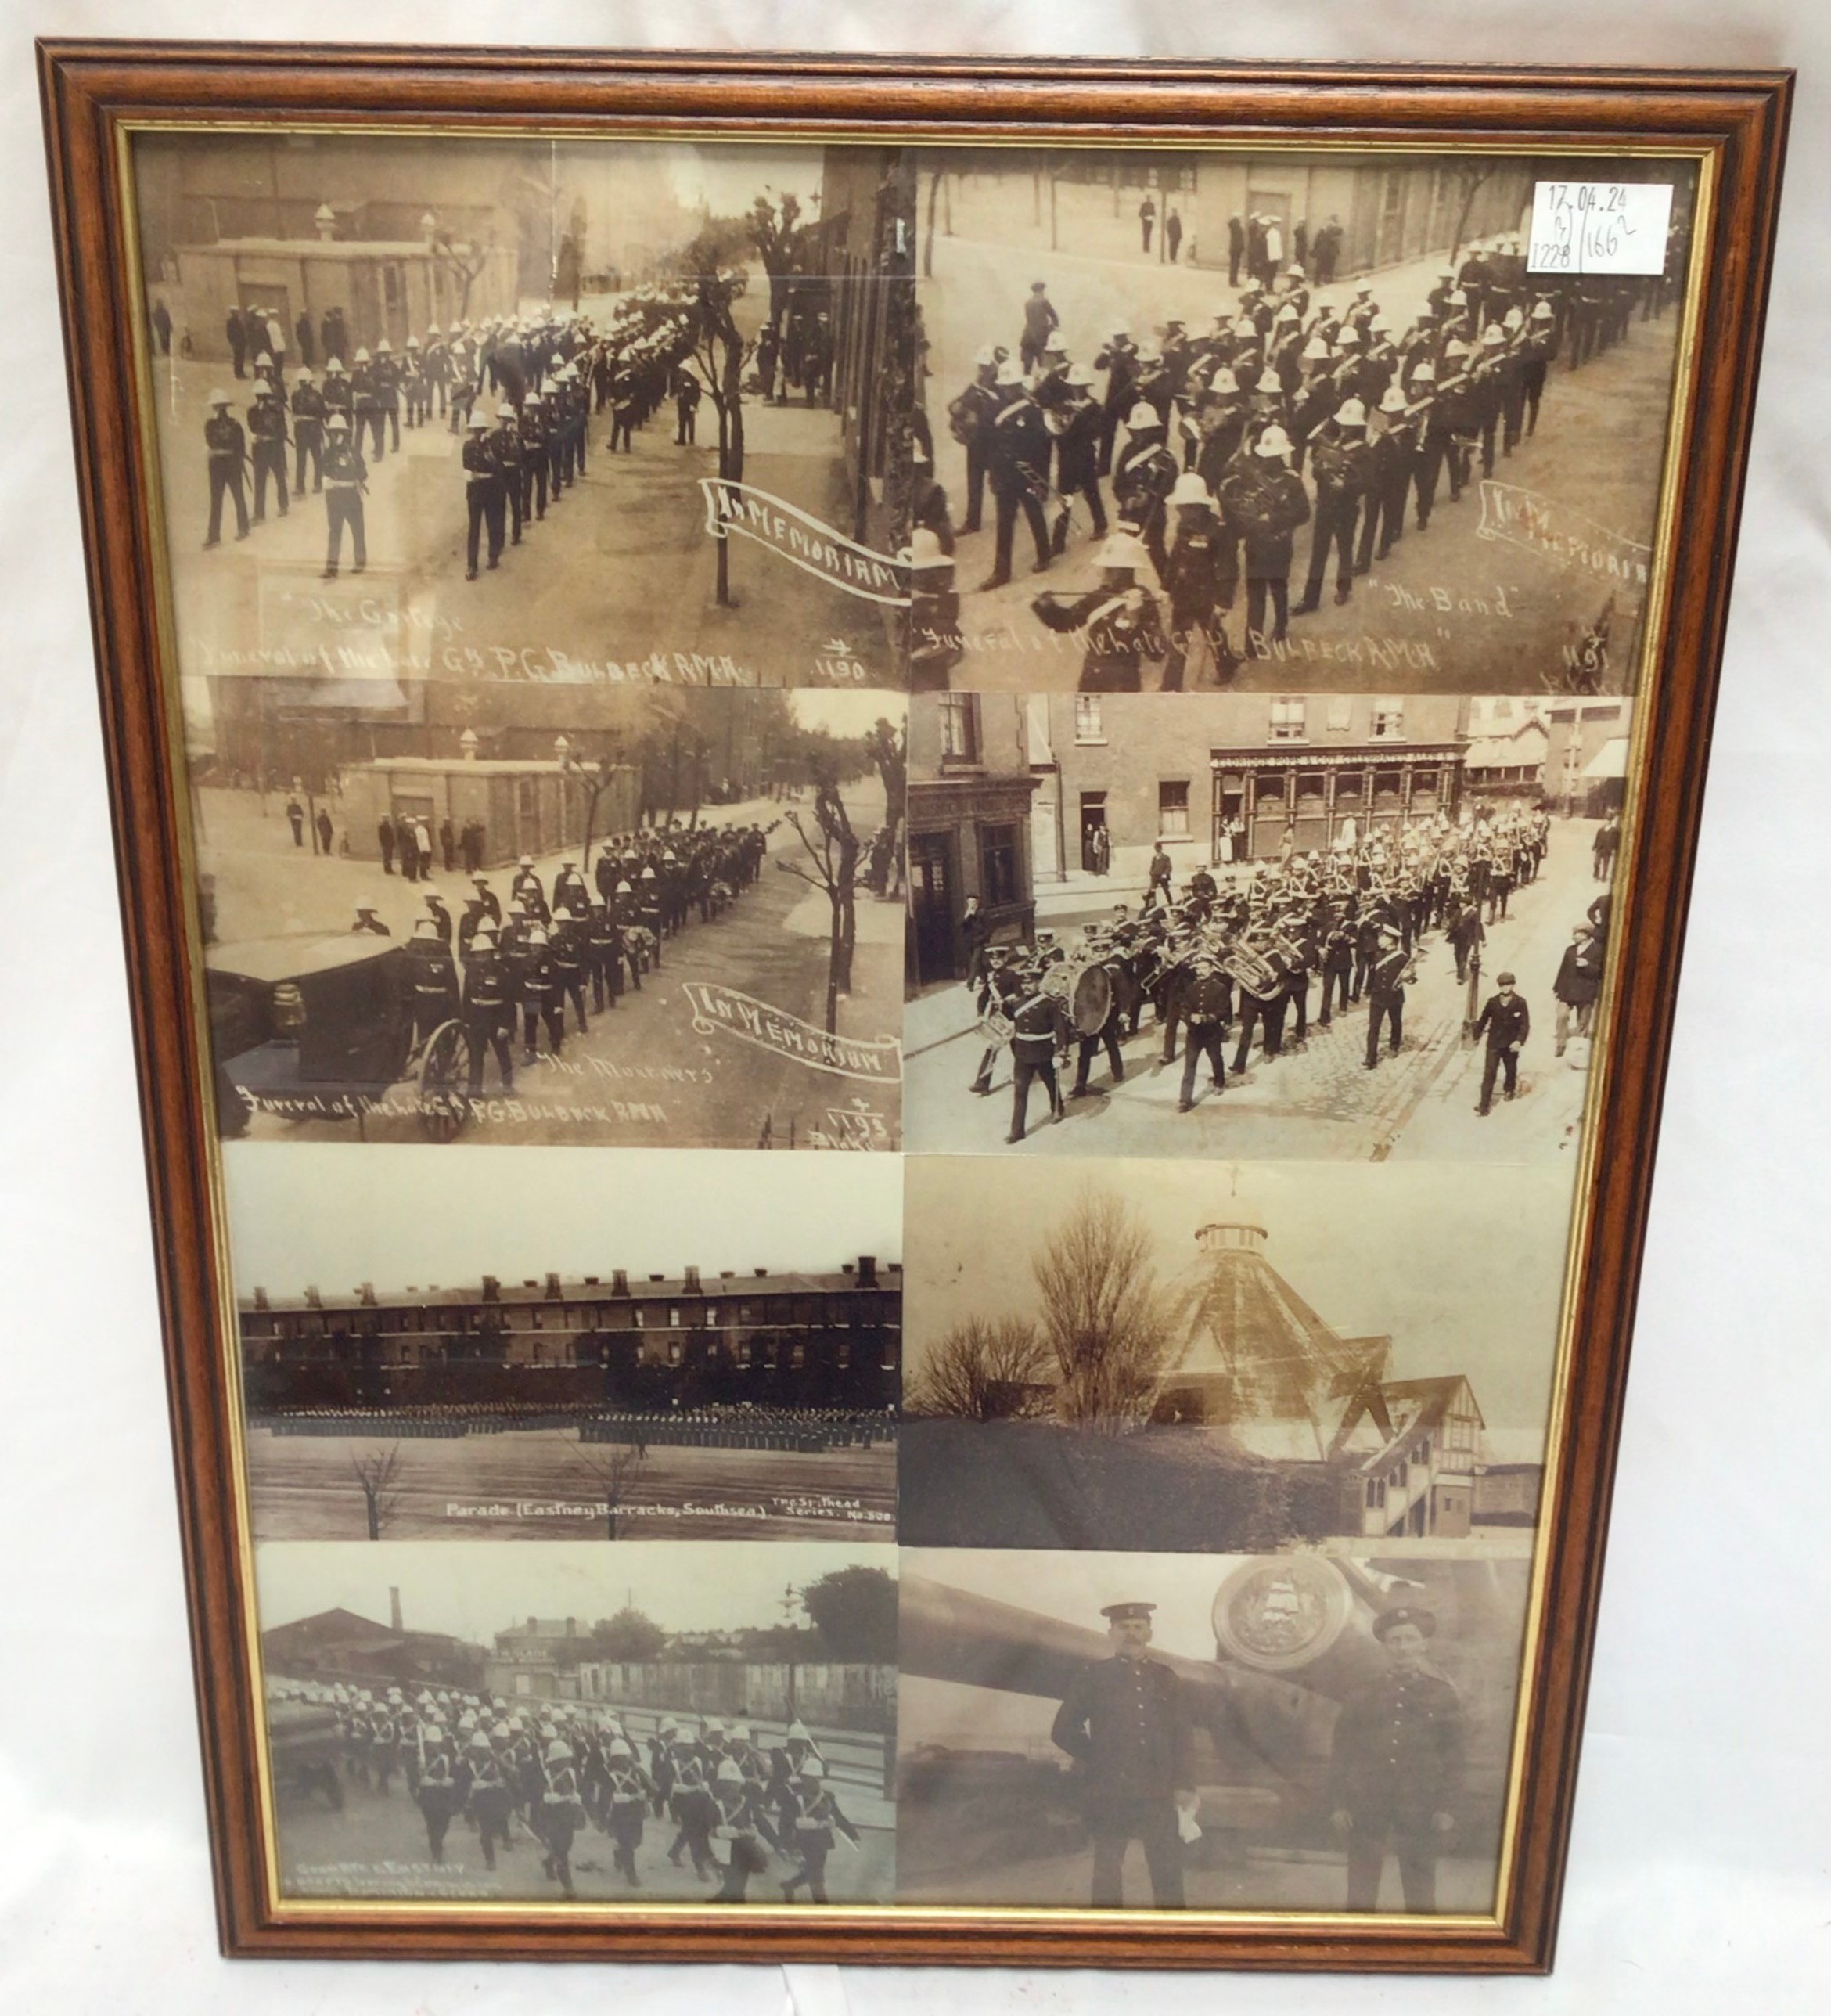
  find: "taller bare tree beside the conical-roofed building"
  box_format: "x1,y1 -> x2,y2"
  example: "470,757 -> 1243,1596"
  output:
1032,1190 -> 1170,1434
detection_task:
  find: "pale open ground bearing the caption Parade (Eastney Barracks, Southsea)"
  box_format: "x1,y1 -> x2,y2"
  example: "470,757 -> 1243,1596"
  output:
248,1427 -> 898,1543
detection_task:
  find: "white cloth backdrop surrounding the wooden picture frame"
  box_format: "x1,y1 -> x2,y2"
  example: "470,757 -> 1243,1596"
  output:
0,0 -> 1831,2016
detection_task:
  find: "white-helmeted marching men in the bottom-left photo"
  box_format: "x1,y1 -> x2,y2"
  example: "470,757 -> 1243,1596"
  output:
270,1679 -> 861,1903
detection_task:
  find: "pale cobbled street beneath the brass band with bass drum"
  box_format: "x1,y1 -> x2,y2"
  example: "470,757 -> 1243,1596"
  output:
904,820 -> 1601,1163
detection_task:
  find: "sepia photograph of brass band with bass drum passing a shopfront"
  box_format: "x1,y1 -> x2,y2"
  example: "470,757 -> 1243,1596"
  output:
904,693 -> 1631,1165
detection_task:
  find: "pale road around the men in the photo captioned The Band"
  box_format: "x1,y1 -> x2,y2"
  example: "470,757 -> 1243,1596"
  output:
923,178 -> 1678,693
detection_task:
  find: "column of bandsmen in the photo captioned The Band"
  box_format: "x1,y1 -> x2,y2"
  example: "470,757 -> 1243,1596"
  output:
918,240 -> 1671,692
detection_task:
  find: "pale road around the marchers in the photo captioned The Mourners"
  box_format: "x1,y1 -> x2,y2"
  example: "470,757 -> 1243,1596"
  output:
212,780 -> 904,1149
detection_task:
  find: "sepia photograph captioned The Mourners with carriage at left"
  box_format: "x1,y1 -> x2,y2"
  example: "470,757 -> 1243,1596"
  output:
196,675 -> 908,1151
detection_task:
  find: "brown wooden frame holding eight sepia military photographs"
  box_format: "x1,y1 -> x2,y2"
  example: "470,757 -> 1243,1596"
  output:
41,42 -> 1790,1971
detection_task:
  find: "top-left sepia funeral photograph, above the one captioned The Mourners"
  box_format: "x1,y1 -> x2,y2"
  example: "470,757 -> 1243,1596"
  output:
133,131 -> 913,686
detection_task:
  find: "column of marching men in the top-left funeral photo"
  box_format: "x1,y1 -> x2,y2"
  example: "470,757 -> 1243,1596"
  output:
203,274 -> 742,581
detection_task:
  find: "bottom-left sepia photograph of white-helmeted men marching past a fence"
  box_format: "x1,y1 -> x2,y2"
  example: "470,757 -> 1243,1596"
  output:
256,1544 -> 898,1905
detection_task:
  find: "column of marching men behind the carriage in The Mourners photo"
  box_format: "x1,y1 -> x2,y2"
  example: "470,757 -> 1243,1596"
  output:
351,823 -> 768,1099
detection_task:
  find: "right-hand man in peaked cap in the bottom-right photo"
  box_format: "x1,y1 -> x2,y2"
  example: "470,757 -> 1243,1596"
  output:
1329,1603 -> 1464,1913
